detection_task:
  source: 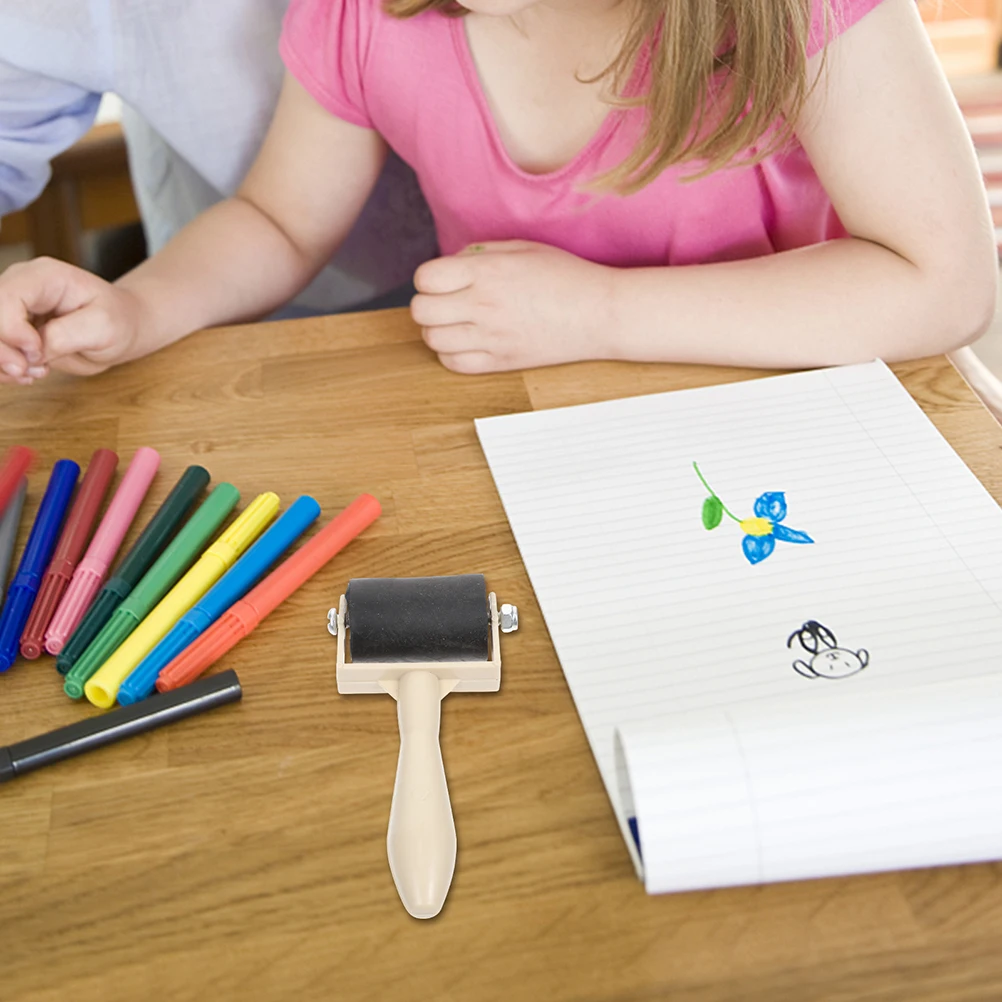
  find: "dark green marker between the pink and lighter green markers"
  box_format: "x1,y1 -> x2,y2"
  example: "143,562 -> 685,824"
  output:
56,466 -> 211,674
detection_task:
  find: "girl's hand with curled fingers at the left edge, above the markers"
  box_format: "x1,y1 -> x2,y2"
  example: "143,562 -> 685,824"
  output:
0,258 -> 139,385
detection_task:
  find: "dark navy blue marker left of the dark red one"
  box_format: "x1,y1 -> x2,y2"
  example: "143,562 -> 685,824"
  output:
0,459 -> 80,671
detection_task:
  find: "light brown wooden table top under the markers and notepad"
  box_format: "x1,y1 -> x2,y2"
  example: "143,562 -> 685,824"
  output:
0,312 -> 1002,1002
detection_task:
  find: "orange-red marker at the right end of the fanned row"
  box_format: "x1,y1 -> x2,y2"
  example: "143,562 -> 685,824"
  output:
156,494 -> 383,692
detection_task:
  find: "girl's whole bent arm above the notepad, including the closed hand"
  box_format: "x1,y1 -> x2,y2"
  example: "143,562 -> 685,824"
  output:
414,0 -> 997,372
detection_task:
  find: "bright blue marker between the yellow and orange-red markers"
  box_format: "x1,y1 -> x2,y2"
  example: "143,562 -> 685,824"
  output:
118,494 -> 320,706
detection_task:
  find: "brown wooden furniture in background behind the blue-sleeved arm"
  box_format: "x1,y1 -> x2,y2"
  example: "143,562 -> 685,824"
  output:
0,122 -> 139,266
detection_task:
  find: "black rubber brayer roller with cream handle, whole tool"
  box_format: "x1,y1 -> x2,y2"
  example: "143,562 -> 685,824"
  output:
329,574 -> 518,919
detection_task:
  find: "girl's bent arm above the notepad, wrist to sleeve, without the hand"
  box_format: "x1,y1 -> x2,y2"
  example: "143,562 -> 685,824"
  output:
601,0 -> 998,367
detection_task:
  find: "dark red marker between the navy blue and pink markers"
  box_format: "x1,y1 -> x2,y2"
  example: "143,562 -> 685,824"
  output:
21,449 -> 118,659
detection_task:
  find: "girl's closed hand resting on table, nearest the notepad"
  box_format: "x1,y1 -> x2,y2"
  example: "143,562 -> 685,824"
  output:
411,240 -> 616,373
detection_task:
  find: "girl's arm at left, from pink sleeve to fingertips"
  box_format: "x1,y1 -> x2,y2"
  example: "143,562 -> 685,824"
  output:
0,77 -> 386,376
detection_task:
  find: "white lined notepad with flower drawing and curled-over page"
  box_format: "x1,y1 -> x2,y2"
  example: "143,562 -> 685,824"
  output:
477,363 -> 1002,893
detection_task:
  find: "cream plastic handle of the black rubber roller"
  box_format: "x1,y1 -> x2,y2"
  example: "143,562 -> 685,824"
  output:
386,671 -> 456,919
